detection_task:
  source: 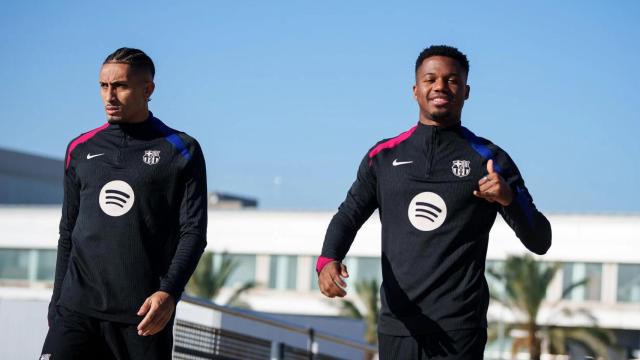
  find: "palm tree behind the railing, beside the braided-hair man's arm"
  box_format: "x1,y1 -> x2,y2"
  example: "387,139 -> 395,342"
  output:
187,252 -> 257,307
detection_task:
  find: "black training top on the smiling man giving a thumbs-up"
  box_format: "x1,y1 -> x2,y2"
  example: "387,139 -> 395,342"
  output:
317,123 -> 551,336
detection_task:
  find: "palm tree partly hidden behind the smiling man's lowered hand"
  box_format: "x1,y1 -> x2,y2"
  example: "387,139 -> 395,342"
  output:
341,279 -> 380,344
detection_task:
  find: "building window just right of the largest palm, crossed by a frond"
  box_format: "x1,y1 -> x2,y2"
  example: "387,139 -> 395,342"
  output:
562,263 -> 602,301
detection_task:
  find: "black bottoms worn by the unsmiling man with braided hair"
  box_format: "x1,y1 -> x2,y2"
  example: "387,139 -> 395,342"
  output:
40,305 -> 173,360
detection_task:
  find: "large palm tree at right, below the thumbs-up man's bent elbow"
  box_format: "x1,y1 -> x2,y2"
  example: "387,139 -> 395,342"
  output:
487,255 -> 615,360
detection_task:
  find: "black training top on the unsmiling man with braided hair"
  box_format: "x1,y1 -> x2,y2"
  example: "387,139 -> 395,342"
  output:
49,113 -> 207,324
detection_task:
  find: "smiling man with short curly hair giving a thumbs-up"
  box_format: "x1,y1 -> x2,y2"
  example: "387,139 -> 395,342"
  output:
316,45 -> 551,359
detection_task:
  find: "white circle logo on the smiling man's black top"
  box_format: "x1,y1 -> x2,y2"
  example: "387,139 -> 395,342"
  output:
409,192 -> 447,231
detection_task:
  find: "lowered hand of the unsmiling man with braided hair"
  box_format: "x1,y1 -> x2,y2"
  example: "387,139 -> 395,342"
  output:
138,291 -> 176,336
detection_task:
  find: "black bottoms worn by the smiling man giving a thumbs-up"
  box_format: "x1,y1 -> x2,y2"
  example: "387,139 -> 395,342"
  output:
378,329 -> 487,360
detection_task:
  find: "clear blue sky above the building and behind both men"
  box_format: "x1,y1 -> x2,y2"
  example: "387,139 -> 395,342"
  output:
0,1 -> 640,212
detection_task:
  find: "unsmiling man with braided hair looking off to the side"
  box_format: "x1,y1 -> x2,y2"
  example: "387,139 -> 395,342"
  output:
41,48 -> 207,359
